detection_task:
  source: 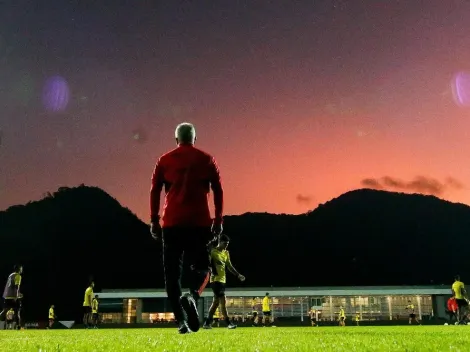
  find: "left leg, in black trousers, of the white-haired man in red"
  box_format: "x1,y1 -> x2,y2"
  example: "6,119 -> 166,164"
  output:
163,228 -> 188,333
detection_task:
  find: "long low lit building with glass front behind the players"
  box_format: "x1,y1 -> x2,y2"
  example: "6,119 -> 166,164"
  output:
99,286 -> 451,323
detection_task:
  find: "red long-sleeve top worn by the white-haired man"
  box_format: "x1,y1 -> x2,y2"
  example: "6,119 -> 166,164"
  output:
150,144 -> 224,227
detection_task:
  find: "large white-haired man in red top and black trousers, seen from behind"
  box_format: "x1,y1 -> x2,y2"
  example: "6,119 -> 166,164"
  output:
150,123 -> 223,334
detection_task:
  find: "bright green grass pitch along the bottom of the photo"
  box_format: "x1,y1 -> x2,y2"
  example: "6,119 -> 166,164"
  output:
0,326 -> 470,352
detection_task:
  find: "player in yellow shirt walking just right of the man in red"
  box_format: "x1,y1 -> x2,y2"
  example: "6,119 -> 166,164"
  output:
204,235 -> 245,329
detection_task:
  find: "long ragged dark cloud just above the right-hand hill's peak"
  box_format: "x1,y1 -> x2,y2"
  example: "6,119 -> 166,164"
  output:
361,176 -> 464,196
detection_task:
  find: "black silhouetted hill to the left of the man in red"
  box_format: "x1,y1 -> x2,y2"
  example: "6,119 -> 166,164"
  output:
0,185 -> 158,319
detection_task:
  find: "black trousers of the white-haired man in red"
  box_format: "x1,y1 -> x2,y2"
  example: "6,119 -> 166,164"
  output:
163,227 -> 213,322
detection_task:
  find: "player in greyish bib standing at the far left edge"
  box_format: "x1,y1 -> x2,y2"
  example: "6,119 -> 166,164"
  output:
0,265 -> 23,329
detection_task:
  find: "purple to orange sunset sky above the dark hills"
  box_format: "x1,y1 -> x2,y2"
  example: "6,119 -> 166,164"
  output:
0,0 -> 470,221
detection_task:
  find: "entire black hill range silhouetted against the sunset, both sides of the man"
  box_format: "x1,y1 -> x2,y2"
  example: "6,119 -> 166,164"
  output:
0,185 -> 470,319
